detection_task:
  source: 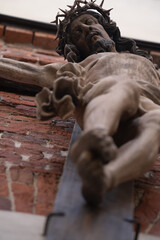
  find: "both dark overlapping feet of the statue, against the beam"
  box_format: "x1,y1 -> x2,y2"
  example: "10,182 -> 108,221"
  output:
71,129 -> 117,206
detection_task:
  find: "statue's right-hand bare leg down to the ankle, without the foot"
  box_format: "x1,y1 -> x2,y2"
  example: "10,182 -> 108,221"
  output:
103,110 -> 160,189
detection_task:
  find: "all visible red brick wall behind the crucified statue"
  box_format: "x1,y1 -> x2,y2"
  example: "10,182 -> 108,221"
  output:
0,21 -> 160,236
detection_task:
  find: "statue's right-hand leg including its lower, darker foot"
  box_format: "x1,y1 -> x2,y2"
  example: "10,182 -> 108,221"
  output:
73,110 -> 160,205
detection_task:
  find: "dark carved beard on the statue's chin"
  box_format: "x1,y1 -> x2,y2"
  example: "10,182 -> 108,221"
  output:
91,39 -> 115,54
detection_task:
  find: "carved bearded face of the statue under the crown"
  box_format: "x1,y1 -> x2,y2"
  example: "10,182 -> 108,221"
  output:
70,14 -> 115,57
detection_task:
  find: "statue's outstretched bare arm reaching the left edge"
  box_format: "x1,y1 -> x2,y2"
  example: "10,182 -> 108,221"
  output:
0,58 -> 63,88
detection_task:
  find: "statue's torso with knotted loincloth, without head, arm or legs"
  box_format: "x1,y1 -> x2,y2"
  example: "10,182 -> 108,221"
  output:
36,53 -> 160,123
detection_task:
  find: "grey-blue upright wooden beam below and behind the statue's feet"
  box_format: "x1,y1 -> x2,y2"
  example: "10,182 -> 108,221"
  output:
46,124 -> 133,240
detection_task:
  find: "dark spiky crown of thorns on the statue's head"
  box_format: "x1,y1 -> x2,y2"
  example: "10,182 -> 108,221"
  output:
53,0 -> 112,55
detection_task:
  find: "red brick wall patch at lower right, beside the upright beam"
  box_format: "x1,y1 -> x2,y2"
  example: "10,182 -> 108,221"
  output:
135,155 -> 160,236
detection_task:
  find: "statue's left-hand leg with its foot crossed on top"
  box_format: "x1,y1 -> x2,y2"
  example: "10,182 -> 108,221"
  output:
71,79 -> 139,162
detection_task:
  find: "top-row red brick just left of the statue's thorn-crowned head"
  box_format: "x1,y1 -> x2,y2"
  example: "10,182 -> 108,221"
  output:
33,32 -> 57,50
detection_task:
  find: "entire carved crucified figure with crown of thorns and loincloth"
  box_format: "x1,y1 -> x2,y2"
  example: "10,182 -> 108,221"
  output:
0,0 -> 160,205
